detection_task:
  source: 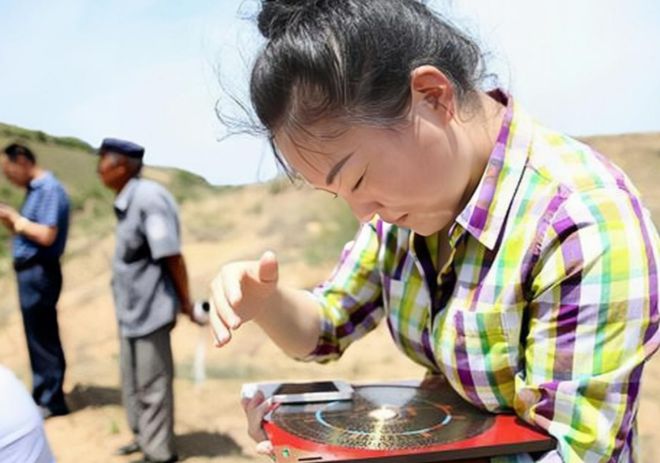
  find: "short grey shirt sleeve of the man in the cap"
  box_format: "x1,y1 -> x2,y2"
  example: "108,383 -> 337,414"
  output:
144,189 -> 181,260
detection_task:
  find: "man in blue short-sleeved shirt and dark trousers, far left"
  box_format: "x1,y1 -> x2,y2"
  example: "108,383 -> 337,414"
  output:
0,143 -> 69,418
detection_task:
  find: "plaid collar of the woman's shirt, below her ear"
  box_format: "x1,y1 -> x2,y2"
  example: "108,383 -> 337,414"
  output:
450,90 -> 533,250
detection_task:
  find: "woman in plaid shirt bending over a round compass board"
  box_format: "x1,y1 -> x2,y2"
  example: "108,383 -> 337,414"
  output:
212,0 -> 660,462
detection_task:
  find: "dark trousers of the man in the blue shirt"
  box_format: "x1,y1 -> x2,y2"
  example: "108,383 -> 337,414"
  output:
16,261 -> 66,413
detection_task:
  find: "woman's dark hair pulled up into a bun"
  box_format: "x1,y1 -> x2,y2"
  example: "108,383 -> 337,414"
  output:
250,0 -> 484,134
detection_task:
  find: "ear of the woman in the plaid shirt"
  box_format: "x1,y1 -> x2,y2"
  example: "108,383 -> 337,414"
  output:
410,65 -> 456,124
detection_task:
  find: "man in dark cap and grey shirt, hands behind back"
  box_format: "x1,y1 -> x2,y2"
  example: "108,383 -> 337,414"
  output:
98,138 -> 192,462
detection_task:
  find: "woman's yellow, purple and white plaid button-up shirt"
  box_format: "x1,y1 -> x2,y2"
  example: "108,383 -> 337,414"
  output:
306,98 -> 660,462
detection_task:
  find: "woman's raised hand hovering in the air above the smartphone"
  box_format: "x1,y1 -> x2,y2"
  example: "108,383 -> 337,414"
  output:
210,251 -> 278,347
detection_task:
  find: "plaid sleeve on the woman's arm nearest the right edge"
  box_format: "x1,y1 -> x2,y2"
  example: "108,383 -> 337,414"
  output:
514,190 -> 660,462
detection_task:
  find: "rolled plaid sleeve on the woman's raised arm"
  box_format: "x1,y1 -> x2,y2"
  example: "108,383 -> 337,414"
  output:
301,221 -> 384,362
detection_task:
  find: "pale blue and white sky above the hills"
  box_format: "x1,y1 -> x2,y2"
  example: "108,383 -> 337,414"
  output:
0,0 -> 660,184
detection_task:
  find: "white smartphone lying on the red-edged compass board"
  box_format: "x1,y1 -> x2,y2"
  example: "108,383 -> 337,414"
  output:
241,380 -> 353,404
